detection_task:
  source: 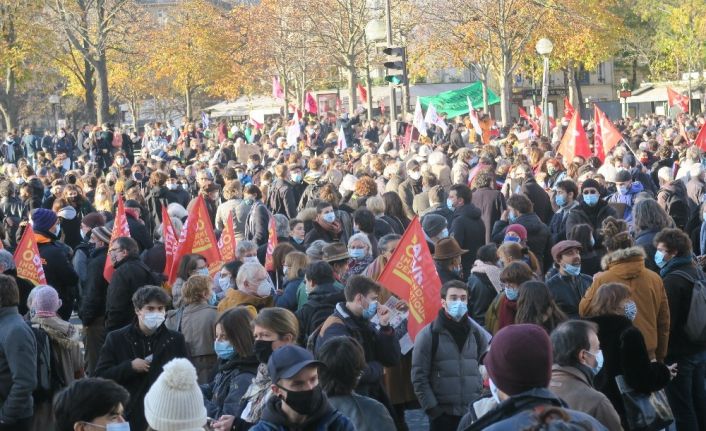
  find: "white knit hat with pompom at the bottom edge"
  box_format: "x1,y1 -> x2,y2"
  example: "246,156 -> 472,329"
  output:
145,358 -> 206,431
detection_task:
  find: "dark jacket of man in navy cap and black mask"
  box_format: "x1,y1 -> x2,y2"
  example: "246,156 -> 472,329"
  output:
250,395 -> 356,431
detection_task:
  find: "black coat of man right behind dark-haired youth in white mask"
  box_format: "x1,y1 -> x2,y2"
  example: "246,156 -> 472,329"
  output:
105,256 -> 159,332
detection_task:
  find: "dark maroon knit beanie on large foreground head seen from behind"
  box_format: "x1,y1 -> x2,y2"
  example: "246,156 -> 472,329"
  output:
483,324 -> 552,396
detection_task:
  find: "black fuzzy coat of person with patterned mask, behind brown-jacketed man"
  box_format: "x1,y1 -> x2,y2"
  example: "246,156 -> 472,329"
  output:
589,314 -> 670,423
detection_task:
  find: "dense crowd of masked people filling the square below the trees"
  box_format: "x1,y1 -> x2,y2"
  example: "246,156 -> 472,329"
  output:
0,111 -> 706,431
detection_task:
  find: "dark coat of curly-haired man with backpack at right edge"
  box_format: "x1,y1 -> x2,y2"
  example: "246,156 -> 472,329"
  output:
656,263 -> 706,364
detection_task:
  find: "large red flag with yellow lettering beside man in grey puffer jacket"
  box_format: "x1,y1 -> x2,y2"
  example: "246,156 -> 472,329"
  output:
378,217 -> 441,341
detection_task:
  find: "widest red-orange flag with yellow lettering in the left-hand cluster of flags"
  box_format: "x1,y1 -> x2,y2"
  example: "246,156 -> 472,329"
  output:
169,195 -> 221,284
